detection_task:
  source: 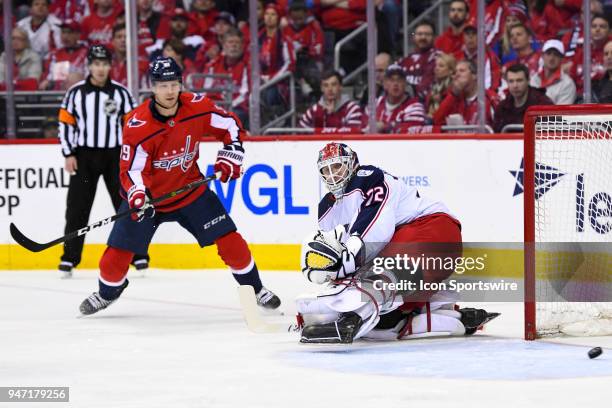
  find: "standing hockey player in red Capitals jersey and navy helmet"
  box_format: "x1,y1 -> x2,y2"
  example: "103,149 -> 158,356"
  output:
80,58 -> 280,315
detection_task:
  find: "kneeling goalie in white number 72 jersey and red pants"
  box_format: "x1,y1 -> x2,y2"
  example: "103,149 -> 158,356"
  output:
297,143 -> 498,343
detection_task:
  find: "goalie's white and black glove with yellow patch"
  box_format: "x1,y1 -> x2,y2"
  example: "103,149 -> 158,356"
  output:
301,225 -> 364,284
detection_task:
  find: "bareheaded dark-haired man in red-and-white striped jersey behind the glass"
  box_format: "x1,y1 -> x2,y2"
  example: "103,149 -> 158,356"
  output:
300,71 -> 363,133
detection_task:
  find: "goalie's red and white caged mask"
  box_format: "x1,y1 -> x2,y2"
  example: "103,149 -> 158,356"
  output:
317,142 -> 359,199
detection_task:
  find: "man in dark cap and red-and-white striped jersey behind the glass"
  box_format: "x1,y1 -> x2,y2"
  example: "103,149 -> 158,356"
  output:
366,64 -> 425,133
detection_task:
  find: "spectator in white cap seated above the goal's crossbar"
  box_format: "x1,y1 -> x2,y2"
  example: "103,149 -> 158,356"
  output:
531,40 -> 576,105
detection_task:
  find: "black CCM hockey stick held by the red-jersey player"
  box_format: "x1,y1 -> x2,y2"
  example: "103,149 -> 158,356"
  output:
10,172 -> 220,252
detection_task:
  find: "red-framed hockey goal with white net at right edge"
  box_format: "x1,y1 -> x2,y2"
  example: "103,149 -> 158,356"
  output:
523,104 -> 612,340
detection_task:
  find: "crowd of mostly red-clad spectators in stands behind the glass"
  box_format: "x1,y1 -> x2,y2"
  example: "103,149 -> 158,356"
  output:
0,0 -> 612,133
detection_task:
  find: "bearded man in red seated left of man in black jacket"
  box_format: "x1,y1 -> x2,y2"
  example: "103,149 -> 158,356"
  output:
433,61 -> 498,126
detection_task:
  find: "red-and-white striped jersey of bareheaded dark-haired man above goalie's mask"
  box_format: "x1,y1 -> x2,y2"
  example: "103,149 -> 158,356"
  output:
300,95 -> 363,133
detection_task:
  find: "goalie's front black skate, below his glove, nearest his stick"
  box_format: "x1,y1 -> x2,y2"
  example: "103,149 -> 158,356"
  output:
300,312 -> 363,344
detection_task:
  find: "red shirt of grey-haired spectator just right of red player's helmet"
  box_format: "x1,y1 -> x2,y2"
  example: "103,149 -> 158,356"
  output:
203,55 -> 251,110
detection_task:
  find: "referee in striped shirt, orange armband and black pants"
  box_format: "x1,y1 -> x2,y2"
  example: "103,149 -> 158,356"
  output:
59,45 -> 149,278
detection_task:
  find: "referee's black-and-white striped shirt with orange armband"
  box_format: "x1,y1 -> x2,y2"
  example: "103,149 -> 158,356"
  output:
59,77 -> 135,157
